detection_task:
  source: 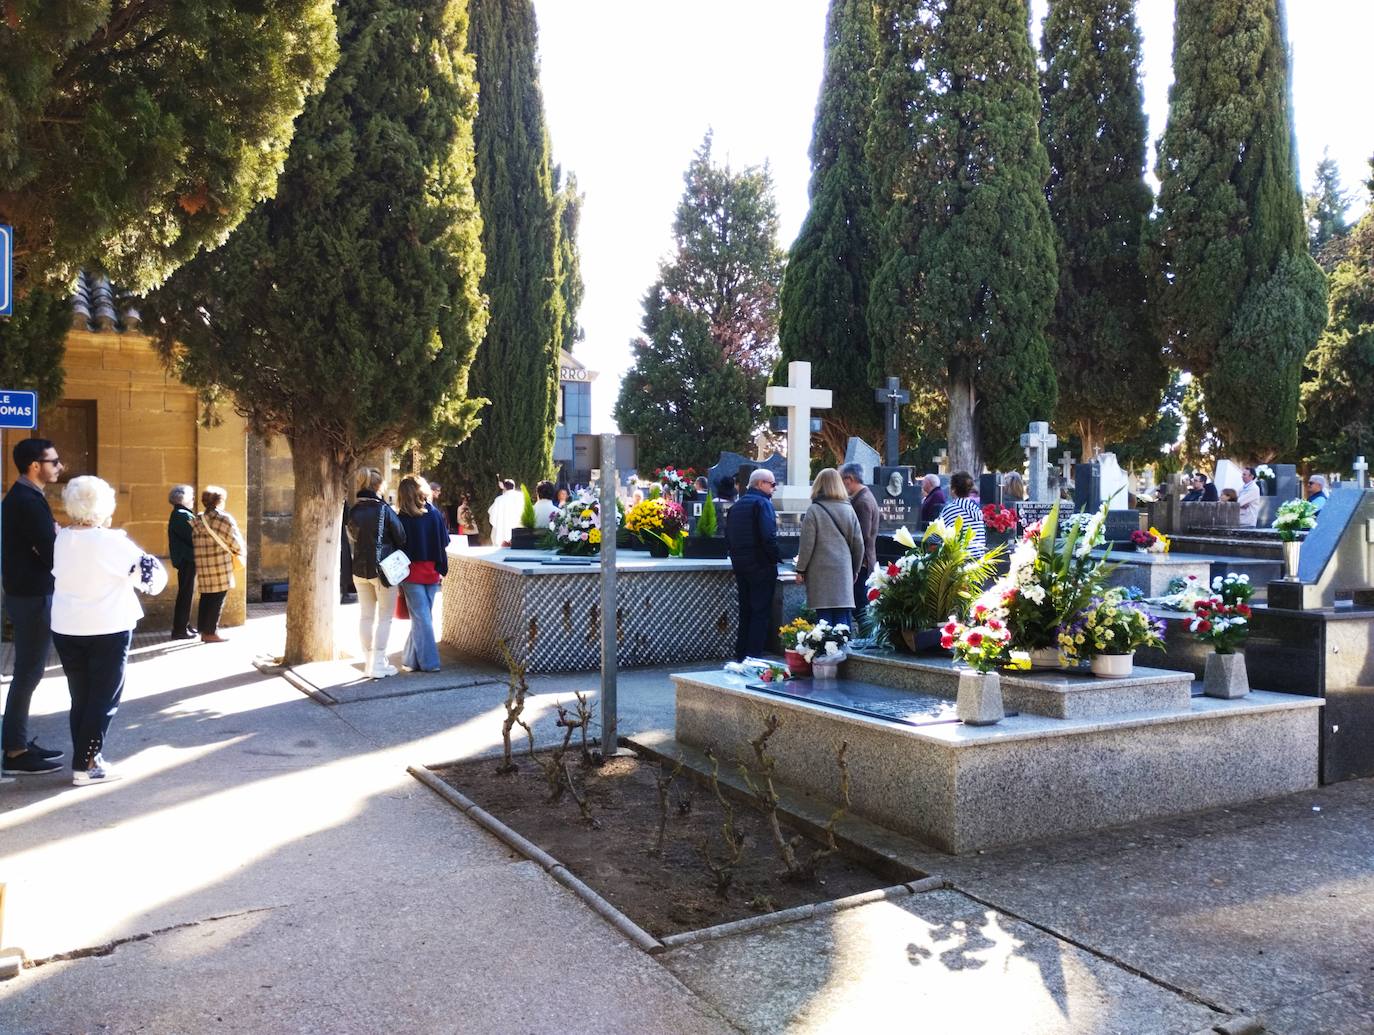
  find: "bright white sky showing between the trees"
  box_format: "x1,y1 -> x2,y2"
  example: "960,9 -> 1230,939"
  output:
534,0 -> 1374,432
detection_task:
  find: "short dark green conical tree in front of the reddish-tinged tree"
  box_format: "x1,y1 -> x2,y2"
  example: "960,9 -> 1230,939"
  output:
616,283 -> 753,470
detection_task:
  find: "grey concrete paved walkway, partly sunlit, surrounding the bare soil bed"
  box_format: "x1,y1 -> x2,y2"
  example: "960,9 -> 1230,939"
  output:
0,610 -> 1374,1035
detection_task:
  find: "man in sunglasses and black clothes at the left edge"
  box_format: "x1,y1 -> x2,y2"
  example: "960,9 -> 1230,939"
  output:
0,438 -> 62,777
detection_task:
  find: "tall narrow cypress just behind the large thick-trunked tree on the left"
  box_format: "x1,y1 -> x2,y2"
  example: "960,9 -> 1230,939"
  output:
444,0 -> 565,514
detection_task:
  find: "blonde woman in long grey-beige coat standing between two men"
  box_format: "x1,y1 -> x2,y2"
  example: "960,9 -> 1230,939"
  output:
797,467 -> 863,630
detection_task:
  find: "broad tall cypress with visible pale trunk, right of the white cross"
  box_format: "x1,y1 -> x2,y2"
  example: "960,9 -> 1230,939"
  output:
868,0 -> 1058,471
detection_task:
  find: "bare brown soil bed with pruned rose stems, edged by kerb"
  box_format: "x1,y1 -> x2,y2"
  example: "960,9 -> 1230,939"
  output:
434,752 -> 900,937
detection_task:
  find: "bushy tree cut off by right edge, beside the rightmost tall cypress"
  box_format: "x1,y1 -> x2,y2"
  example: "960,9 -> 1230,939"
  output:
1300,159 -> 1374,469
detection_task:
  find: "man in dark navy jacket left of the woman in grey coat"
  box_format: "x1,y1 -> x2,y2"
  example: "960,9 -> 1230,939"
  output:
725,467 -> 782,661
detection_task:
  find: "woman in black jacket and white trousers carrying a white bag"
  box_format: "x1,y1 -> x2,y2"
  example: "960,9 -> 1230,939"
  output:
348,467 -> 405,679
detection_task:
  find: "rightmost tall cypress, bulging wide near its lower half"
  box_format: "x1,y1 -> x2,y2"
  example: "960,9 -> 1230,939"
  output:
1151,0 -> 1326,456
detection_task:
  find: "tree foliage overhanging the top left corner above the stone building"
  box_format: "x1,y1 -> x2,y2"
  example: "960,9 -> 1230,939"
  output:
0,0 -> 338,399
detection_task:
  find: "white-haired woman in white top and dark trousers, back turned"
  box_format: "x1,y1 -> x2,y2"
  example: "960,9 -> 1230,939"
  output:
52,476 -> 168,788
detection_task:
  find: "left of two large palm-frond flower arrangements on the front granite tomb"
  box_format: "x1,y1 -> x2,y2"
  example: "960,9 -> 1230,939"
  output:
867,518 -> 1003,650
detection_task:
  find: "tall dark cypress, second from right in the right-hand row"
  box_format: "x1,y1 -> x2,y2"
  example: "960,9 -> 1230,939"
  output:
1040,0 -> 1168,455
